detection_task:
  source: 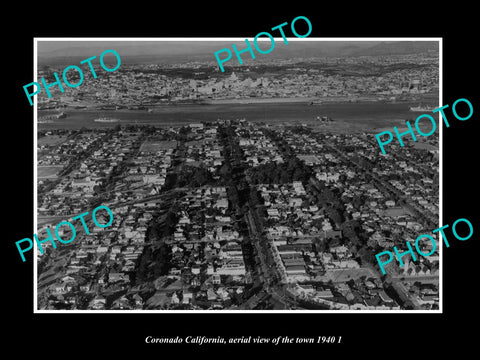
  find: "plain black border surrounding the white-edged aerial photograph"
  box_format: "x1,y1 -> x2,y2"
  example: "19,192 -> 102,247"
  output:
6,3 -> 480,356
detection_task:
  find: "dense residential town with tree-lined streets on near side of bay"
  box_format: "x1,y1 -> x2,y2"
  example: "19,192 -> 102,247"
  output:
37,119 -> 439,310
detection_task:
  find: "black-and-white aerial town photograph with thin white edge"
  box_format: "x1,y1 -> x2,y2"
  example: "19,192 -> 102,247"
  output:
31,37 -> 440,311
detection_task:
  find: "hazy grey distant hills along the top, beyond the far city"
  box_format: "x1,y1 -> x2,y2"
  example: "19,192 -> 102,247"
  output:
38,40 -> 438,65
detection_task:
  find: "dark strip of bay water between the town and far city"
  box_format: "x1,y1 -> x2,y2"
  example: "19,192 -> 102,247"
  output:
39,102 -> 438,131
